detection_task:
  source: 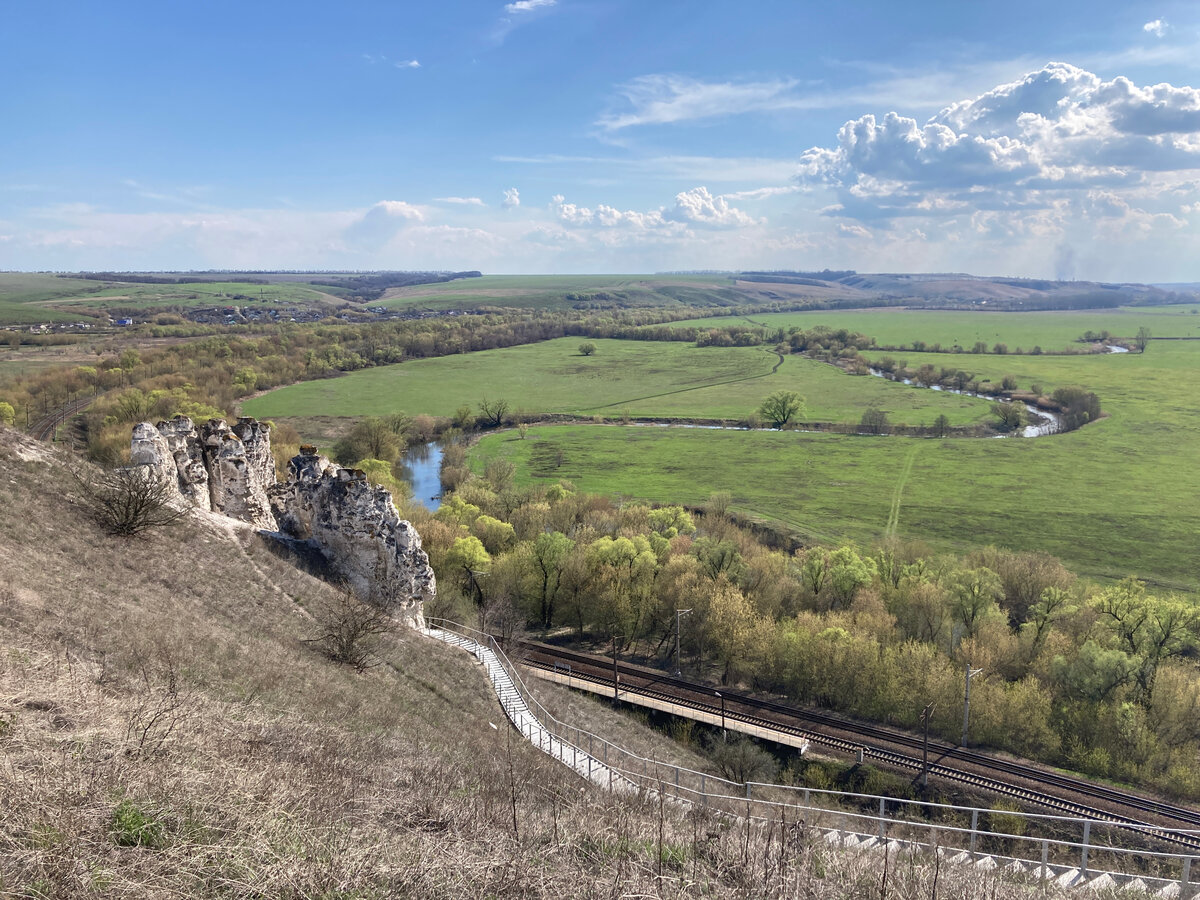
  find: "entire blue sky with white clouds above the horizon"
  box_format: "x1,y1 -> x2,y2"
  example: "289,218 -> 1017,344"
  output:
0,0 -> 1200,282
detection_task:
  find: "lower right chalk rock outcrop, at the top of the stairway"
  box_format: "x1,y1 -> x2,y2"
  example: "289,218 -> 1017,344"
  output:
271,446 -> 437,626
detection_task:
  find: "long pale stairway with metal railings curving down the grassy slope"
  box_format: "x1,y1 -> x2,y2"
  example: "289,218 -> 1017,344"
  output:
426,618 -> 1200,898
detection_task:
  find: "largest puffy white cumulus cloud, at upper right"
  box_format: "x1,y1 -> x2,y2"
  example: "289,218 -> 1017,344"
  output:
799,62 -> 1200,221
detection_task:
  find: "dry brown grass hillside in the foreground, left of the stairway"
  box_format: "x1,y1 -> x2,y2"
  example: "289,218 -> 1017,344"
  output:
0,430 -> 1099,898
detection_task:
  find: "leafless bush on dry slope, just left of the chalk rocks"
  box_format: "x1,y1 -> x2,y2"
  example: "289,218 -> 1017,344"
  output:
73,466 -> 190,536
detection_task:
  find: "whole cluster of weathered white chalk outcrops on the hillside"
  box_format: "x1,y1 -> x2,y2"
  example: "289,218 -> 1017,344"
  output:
131,416 -> 437,624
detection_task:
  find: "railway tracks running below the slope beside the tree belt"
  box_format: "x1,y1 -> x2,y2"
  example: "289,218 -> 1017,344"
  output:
522,643 -> 1200,851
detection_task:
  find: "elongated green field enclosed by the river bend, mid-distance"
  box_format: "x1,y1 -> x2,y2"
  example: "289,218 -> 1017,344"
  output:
242,338 -> 989,425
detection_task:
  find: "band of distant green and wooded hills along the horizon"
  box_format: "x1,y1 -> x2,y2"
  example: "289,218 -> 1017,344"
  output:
0,270 -> 1200,326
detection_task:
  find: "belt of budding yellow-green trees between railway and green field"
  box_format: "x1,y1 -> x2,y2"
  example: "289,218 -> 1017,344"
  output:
396,458 -> 1200,797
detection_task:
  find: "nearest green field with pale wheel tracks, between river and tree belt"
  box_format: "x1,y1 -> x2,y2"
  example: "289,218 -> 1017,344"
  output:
473,342 -> 1200,589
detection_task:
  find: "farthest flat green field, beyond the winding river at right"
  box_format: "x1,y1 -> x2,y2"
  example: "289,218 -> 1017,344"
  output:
672,304 -> 1200,352
